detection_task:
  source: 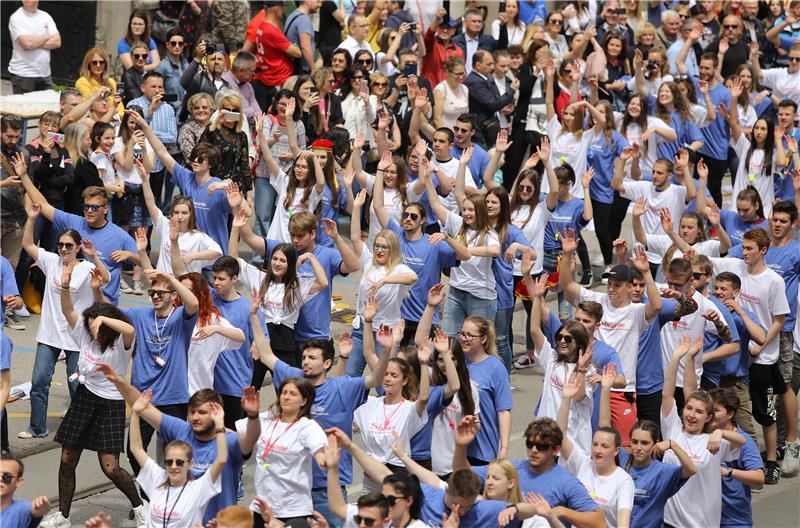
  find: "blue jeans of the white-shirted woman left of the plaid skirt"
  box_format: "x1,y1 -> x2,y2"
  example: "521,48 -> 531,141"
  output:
28,343 -> 80,437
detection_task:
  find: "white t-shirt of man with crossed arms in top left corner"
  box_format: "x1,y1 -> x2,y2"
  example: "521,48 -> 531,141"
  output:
8,7 -> 58,77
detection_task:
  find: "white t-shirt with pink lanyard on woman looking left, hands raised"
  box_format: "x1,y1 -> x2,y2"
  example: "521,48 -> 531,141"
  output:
353,396 -> 428,466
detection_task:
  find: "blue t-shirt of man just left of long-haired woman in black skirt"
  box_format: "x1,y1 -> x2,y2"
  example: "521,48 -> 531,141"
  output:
211,289 -> 256,398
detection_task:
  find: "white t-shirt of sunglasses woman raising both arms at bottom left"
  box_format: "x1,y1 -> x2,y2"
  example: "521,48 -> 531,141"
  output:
136,458 -> 222,528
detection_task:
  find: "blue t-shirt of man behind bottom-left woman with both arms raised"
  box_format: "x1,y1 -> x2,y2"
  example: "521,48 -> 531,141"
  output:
158,414 -> 244,525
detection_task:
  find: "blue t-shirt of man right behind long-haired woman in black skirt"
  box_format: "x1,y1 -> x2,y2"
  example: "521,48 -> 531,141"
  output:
264,238 -> 344,342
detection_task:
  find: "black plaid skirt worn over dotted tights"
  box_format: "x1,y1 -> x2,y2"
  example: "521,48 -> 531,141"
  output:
55,385 -> 125,453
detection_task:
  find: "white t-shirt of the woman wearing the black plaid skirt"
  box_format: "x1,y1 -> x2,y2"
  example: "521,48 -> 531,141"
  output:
69,317 -> 136,400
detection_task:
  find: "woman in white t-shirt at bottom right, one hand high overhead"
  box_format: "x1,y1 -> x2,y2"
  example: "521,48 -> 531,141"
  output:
661,337 -> 745,526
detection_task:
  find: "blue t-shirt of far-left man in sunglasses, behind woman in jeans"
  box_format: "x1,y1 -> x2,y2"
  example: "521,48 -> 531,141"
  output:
53,209 -> 136,304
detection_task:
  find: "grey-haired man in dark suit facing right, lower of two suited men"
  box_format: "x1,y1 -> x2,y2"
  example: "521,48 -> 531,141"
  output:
464,50 -> 519,146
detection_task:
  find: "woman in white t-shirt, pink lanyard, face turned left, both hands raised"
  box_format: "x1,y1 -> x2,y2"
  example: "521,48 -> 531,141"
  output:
353,324 -> 431,491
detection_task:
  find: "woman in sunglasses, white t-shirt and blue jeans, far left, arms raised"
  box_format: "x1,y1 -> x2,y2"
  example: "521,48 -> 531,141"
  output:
17,204 -> 110,439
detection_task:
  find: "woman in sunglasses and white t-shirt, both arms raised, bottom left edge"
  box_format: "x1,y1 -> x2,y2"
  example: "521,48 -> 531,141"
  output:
129,391 -> 228,528
